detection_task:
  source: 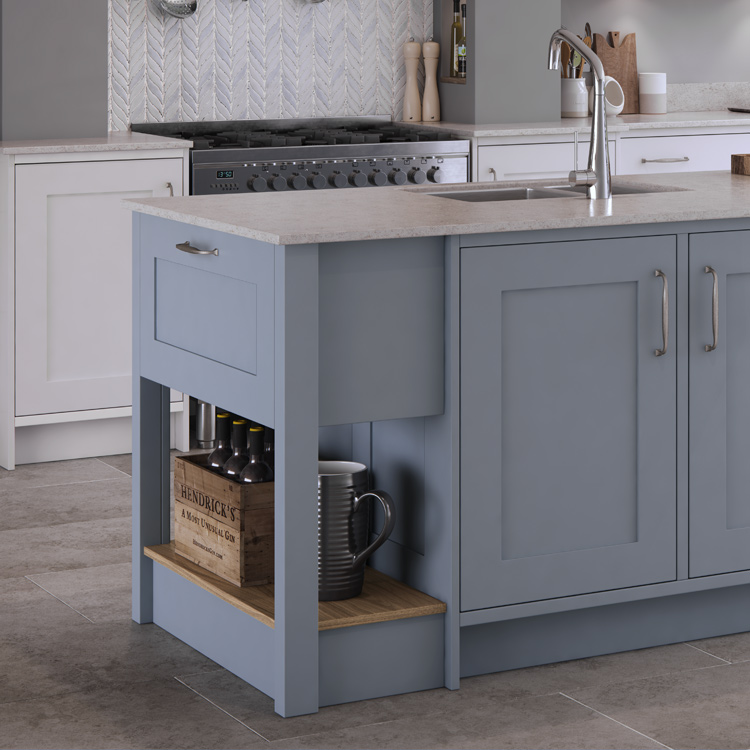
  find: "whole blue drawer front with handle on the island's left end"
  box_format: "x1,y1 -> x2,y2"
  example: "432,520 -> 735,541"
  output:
136,215 -> 275,427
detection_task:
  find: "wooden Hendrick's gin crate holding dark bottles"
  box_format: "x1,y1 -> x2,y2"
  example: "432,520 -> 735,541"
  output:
174,453 -> 274,586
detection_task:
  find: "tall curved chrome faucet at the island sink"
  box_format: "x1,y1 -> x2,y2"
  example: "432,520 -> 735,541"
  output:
549,29 -> 612,200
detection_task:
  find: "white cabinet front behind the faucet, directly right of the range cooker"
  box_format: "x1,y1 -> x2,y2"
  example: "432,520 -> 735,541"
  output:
477,144 -> 617,182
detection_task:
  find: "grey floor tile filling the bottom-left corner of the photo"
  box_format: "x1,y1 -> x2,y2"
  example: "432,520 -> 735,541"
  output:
0,680 -> 268,750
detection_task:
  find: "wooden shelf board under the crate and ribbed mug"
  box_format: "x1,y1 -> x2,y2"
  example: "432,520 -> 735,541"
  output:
143,542 -> 446,630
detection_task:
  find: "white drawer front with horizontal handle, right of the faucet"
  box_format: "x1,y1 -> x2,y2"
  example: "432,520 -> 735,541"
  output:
618,133 -> 750,174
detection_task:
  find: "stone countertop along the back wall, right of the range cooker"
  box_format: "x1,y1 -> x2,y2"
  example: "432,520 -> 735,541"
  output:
421,110 -> 750,138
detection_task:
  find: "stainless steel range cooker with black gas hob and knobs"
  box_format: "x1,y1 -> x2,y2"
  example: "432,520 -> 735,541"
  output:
131,117 -> 469,195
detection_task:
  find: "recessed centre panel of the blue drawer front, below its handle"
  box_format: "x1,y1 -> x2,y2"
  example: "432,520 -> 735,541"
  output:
154,258 -> 258,375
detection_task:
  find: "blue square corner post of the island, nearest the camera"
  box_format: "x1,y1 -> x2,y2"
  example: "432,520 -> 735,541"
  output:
274,245 -> 318,716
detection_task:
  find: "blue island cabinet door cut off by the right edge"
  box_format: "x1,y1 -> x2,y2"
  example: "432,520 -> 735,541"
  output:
690,232 -> 750,576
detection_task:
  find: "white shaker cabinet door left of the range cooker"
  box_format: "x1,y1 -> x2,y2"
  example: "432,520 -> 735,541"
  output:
15,158 -> 183,416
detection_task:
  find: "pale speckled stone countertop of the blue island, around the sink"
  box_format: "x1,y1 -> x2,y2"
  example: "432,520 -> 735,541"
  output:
128,172 -> 750,245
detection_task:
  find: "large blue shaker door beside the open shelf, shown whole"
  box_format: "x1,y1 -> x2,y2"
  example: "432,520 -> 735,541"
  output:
461,236 -> 676,611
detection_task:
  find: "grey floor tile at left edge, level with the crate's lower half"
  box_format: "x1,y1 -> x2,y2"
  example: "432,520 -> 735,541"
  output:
0,517 -> 132,578
